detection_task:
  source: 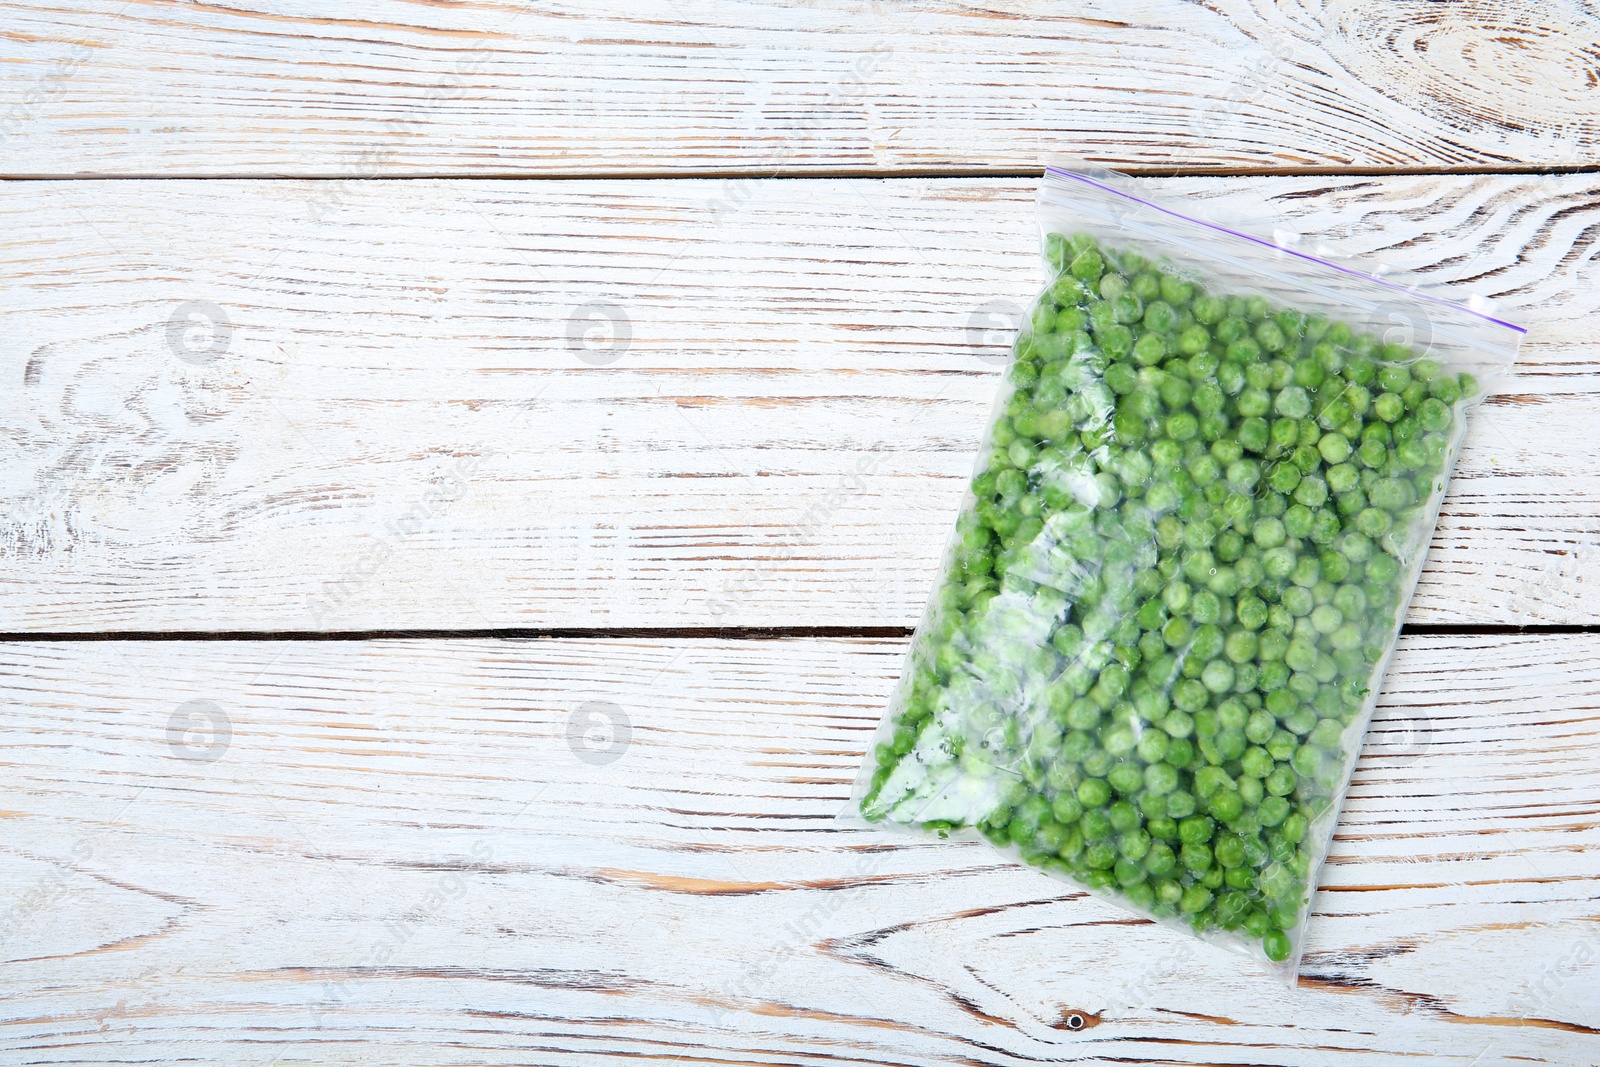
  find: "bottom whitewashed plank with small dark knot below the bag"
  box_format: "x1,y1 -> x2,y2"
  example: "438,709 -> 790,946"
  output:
0,635 -> 1600,1067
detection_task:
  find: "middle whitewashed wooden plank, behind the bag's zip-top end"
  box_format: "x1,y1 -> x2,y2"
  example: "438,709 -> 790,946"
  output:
0,176 -> 1600,632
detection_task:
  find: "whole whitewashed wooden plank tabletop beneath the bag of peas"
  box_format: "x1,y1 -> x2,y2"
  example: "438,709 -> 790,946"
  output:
0,0 -> 1600,1067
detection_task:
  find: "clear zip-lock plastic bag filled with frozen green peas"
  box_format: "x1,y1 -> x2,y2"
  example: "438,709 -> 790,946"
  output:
845,166 -> 1523,981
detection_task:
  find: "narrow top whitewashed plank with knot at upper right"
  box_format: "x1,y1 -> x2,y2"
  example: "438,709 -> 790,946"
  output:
0,0 -> 1600,176
